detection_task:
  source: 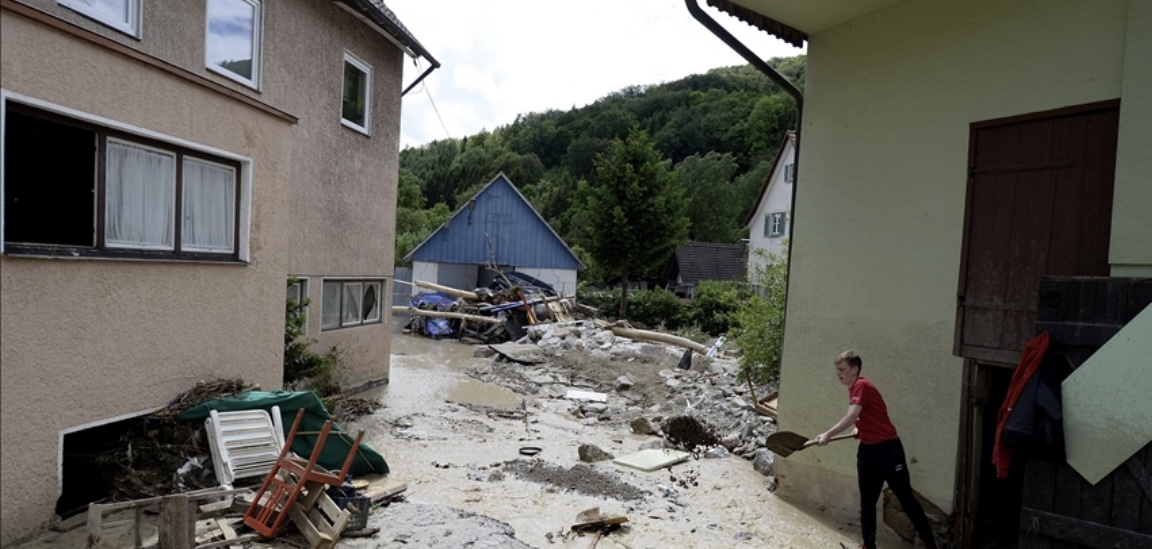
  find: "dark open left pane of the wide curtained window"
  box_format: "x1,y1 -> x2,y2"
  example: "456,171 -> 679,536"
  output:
5,109 -> 97,246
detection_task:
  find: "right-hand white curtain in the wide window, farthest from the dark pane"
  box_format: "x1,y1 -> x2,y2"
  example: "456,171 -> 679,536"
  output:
180,159 -> 236,253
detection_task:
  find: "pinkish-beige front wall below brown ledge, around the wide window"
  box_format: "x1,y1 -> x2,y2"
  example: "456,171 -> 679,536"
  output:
0,10 -> 294,546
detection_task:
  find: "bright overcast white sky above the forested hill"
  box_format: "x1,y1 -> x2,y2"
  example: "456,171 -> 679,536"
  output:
387,0 -> 803,148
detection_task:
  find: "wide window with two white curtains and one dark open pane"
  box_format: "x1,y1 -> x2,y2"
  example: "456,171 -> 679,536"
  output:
3,101 -> 241,260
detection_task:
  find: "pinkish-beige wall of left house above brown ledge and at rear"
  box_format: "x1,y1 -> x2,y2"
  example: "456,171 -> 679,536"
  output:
13,0 -> 403,387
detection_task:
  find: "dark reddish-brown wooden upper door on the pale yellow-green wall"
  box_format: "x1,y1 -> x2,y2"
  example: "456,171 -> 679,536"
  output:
955,101 -> 1120,365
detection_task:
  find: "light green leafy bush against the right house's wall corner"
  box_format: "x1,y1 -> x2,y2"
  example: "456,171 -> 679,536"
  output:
730,250 -> 788,383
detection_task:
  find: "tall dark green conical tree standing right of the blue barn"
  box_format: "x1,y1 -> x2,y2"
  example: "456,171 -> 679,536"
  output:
588,127 -> 688,319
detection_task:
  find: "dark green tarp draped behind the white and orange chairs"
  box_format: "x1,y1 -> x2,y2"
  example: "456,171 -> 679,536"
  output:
176,390 -> 388,476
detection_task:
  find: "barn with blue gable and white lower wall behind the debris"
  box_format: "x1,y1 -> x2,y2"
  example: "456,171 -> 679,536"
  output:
404,173 -> 585,296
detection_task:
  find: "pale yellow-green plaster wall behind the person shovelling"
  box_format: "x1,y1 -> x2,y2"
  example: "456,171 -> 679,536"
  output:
770,0 -> 1133,517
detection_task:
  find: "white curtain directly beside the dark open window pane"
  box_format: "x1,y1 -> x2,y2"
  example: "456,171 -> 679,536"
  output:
104,139 -> 176,250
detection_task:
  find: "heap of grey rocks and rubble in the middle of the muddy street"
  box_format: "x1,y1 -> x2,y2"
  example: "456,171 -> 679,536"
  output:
468,320 -> 776,474
